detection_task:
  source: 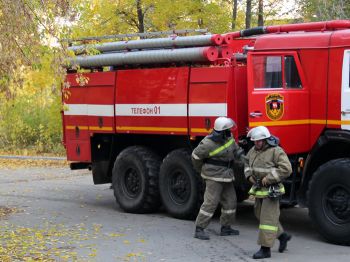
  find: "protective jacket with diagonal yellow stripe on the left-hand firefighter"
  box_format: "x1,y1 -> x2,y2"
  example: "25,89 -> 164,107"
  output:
192,135 -> 243,182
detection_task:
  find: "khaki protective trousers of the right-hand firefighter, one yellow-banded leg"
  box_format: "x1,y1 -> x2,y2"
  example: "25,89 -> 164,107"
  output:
254,198 -> 284,247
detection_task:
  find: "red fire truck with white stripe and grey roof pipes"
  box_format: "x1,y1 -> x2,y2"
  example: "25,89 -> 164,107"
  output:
62,20 -> 350,244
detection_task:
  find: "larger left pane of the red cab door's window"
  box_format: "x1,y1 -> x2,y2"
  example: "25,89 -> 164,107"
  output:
253,56 -> 283,88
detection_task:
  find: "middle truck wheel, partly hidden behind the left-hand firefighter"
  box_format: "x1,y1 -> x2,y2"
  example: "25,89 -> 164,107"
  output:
159,149 -> 204,219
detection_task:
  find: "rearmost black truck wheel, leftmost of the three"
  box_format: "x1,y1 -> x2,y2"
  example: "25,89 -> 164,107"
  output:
112,146 -> 161,213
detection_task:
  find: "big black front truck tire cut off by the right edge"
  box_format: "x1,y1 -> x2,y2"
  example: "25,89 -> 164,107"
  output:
308,158 -> 350,245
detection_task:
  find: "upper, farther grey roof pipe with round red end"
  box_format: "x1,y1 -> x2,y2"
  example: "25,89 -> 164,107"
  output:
68,34 -> 223,54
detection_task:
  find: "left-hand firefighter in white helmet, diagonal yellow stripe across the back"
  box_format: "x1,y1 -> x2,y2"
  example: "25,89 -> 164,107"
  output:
192,117 -> 243,240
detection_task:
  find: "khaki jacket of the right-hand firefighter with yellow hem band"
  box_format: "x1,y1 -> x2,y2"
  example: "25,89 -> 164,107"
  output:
244,144 -> 292,198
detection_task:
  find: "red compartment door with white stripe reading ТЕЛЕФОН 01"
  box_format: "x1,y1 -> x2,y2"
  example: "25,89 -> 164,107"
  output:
115,67 -> 189,135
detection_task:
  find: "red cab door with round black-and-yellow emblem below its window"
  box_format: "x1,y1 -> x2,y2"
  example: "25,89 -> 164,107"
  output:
248,52 -> 310,154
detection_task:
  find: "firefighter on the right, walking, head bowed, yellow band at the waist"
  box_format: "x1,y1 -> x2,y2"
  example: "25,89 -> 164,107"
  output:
244,126 -> 292,259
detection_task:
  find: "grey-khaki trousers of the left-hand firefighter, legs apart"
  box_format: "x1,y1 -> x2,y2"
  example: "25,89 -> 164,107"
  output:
196,179 -> 237,228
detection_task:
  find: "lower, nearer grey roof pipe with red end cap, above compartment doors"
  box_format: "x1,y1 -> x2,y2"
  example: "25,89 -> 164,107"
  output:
69,46 -> 219,68
